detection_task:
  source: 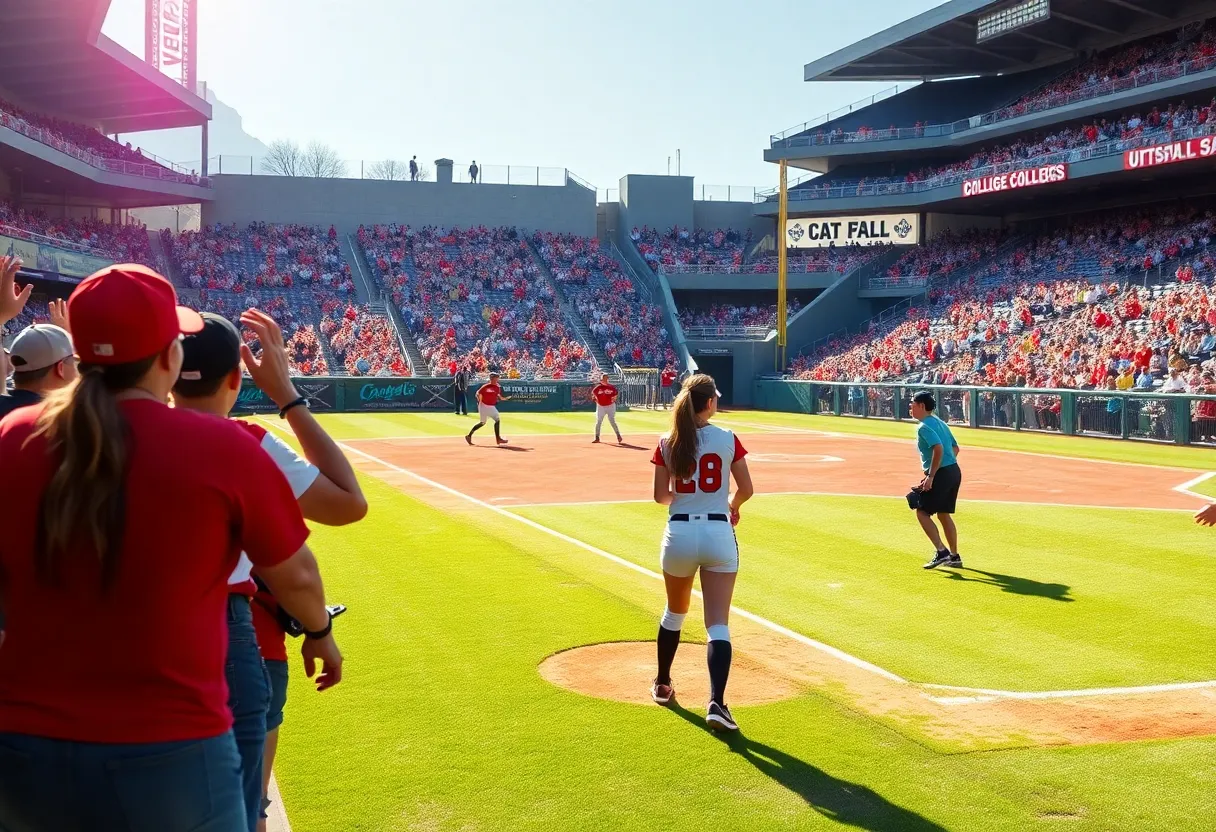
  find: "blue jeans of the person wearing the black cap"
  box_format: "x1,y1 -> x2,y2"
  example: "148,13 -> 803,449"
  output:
225,595 -> 270,832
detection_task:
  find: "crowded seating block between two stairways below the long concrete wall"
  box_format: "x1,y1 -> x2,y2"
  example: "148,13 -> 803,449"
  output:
358,225 -> 592,378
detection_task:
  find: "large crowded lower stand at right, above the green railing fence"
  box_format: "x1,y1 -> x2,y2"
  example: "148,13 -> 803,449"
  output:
792,206 -> 1216,408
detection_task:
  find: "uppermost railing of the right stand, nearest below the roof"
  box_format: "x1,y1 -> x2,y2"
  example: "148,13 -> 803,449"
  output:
769,56 -> 1216,148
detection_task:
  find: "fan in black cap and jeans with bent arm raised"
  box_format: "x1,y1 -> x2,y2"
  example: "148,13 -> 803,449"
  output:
173,309 -> 367,832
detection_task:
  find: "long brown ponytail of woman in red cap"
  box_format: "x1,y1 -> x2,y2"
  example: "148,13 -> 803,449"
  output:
33,356 -> 157,588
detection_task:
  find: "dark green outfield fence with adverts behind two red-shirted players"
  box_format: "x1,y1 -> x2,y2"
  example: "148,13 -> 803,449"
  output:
233,376 -> 654,414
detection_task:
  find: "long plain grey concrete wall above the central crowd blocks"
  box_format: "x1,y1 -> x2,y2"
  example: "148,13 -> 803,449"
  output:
203,175 -> 596,237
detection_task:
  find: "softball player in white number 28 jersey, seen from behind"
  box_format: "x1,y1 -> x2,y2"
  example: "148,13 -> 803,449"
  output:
651,375 -> 753,731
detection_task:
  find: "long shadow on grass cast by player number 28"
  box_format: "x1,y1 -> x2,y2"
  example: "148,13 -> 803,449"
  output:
669,702 -> 946,832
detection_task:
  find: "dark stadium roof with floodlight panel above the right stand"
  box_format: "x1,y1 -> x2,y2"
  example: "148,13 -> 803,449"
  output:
804,0 -> 1216,80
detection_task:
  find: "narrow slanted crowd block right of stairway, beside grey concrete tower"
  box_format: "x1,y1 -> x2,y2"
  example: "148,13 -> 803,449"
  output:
533,231 -> 675,367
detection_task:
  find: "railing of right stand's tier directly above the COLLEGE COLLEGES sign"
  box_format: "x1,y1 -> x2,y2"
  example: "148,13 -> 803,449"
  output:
756,123 -> 1216,202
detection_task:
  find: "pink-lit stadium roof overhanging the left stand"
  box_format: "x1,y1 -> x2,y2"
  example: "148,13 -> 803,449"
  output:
0,0 -> 212,133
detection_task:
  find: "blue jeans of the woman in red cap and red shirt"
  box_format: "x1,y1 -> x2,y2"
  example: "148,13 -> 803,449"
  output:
0,731 -> 246,832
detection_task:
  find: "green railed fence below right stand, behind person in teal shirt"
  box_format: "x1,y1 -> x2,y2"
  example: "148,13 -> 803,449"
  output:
754,380 -> 1216,446
